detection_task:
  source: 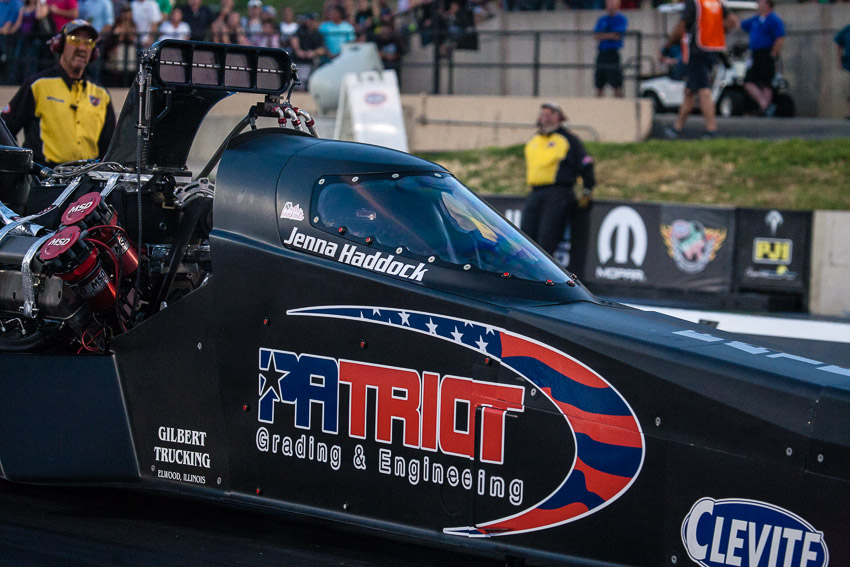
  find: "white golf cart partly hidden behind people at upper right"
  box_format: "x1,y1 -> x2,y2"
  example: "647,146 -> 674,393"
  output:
639,1 -> 795,117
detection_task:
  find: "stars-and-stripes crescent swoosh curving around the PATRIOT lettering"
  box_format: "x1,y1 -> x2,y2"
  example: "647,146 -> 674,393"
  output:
287,305 -> 645,537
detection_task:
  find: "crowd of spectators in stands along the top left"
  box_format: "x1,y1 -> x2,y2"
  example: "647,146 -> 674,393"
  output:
0,0 -> 496,86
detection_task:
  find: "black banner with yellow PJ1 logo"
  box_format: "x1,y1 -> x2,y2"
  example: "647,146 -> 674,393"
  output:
735,209 -> 812,291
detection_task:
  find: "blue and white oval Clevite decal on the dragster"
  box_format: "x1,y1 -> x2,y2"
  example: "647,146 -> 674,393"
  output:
682,498 -> 829,567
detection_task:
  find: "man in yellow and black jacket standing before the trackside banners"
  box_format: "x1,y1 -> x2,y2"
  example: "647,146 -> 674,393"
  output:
520,102 -> 596,254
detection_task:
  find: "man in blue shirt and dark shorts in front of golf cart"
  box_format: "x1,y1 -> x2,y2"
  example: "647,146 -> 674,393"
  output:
741,0 -> 785,116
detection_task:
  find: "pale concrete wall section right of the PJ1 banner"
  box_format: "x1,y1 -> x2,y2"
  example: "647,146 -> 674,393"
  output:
809,211 -> 850,317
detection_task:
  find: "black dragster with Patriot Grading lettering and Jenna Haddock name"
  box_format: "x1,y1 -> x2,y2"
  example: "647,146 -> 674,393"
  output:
0,42 -> 850,567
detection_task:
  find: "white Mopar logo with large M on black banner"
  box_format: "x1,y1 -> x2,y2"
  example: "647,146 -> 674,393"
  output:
596,206 -> 646,281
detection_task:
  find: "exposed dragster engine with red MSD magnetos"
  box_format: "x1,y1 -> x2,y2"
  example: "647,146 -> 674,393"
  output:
0,169 -> 214,353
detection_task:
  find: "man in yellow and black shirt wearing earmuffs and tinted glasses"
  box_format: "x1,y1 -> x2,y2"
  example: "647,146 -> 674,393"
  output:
0,20 -> 115,166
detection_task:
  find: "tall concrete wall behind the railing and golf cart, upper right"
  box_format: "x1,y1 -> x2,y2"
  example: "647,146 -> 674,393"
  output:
402,3 -> 850,118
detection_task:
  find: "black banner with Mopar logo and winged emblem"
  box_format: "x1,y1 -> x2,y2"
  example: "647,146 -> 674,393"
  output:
584,203 -> 734,292
